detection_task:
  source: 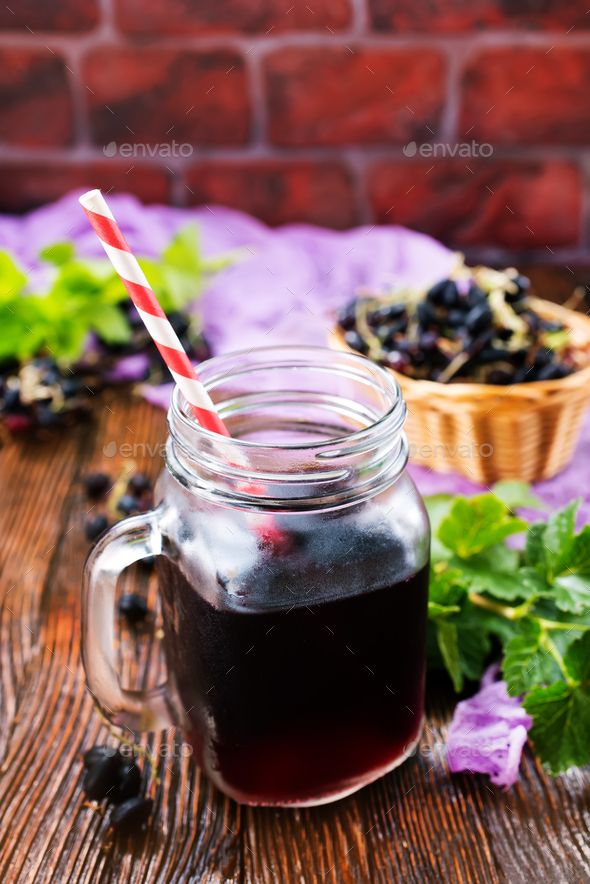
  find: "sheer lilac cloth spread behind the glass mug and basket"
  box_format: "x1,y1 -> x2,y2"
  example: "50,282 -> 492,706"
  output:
0,193 -> 590,522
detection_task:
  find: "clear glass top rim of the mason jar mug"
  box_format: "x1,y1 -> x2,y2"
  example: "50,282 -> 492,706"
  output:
168,344 -> 406,456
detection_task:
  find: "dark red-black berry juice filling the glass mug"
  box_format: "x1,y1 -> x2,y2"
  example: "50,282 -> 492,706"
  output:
159,520 -> 428,805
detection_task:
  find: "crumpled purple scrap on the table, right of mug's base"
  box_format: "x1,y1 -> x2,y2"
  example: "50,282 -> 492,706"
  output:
447,666 -> 533,789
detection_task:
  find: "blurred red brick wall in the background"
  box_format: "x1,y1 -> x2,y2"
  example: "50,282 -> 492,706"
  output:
0,0 -> 590,264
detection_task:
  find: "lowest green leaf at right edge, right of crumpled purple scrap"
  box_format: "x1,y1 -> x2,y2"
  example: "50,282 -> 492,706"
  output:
524,633 -> 590,774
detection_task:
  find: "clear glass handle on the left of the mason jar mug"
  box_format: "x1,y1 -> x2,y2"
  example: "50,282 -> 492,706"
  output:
82,510 -> 181,733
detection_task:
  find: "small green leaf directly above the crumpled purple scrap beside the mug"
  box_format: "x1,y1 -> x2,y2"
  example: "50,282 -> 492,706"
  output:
502,618 -> 561,697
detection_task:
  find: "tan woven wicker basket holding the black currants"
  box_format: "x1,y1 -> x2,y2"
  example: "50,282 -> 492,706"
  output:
331,298 -> 590,483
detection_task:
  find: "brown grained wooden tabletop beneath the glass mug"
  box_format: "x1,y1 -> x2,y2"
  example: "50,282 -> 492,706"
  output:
0,394 -> 590,884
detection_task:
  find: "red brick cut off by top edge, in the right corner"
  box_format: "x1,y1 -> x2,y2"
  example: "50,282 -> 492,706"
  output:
369,0 -> 590,34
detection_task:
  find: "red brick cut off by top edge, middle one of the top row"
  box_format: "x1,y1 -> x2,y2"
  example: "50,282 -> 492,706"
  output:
115,0 -> 351,37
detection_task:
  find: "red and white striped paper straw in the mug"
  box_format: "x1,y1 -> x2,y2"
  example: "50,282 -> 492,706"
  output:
80,190 -> 230,436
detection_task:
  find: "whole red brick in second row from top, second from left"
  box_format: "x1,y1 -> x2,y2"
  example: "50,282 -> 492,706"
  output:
83,47 -> 250,146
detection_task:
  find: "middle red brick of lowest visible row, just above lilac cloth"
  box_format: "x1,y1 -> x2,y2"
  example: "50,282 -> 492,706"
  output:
187,161 -> 358,228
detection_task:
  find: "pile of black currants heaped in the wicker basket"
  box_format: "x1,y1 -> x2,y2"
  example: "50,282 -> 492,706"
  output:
338,264 -> 579,385
